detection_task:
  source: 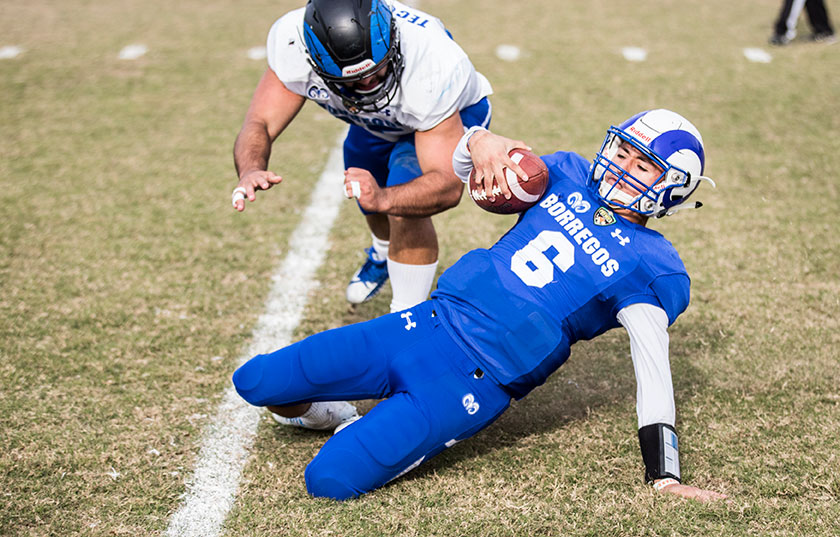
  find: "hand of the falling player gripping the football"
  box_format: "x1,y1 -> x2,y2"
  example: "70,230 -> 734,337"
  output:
467,131 -> 531,201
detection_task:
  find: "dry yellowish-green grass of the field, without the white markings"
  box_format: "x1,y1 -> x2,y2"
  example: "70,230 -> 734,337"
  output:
0,0 -> 840,537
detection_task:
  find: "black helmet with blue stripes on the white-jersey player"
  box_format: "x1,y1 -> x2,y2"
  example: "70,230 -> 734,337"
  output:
303,0 -> 404,113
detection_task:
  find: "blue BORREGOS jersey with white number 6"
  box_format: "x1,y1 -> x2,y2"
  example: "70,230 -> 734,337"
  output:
432,152 -> 690,398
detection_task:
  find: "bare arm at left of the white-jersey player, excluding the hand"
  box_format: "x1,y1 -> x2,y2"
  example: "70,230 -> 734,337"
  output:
233,69 -> 306,178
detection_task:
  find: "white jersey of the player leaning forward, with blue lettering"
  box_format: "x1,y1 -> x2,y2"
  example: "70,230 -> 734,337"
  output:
267,2 -> 493,141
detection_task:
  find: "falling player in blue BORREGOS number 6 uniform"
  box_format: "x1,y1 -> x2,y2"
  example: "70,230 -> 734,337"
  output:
233,110 -> 723,500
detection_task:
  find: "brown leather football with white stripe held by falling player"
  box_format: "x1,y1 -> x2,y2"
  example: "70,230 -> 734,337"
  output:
469,149 -> 548,214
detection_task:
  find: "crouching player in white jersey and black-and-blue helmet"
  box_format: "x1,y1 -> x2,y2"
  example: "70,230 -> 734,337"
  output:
233,0 -> 492,322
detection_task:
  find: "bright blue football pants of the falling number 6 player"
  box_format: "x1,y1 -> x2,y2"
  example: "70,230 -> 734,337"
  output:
233,301 -> 510,500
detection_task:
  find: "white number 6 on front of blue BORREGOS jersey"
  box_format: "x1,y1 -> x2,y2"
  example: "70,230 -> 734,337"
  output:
510,231 -> 575,288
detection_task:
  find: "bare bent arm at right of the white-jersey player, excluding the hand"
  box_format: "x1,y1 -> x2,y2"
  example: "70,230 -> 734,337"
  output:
375,112 -> 464,216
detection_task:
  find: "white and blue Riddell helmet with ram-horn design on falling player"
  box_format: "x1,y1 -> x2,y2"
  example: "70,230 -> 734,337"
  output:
589,109 -> 715,218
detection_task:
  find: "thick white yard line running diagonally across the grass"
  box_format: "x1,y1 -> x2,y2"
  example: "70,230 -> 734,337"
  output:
166,133 -> 345,537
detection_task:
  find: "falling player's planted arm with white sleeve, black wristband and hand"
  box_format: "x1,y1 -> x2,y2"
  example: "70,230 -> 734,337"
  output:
617,303 -> 726,501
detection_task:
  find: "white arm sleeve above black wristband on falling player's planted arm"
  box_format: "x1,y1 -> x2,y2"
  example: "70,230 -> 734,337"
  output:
618,303 -> 676,428
